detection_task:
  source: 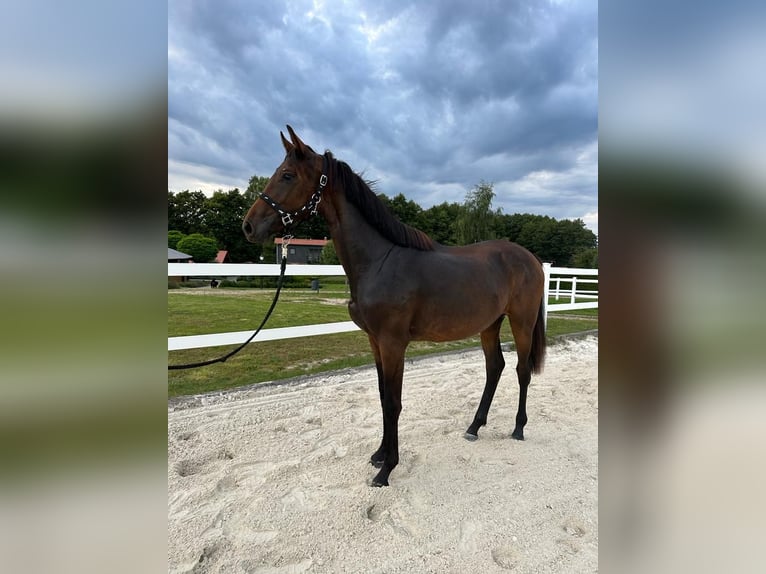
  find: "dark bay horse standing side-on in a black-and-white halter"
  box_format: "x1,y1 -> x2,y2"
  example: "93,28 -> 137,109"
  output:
242,125 -> 546,486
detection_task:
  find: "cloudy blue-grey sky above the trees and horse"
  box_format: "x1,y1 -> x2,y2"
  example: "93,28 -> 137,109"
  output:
168,0 -> 598,232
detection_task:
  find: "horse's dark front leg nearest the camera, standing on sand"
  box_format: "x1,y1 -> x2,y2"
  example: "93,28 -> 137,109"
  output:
371,345 -> 406,486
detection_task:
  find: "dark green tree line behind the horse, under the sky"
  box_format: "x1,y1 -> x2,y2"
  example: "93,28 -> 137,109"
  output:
168,176 -> 598,267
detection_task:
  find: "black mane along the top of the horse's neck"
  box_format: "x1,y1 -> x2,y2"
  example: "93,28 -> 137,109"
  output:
325,151 -> 434,251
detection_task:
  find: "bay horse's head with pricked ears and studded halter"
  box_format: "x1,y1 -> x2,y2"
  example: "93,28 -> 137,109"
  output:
242,126 -> 327,243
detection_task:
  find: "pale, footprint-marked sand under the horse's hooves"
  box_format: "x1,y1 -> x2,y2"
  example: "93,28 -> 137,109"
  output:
168,337 -> 598,574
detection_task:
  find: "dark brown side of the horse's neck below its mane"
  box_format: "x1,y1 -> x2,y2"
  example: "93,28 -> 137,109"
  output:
322,190 -> 392,286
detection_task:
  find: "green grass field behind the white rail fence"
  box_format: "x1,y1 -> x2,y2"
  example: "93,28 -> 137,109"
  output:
168,288 -> 598,397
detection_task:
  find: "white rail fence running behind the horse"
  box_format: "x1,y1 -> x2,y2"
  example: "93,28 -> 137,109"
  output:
168,263 -> 598,351
